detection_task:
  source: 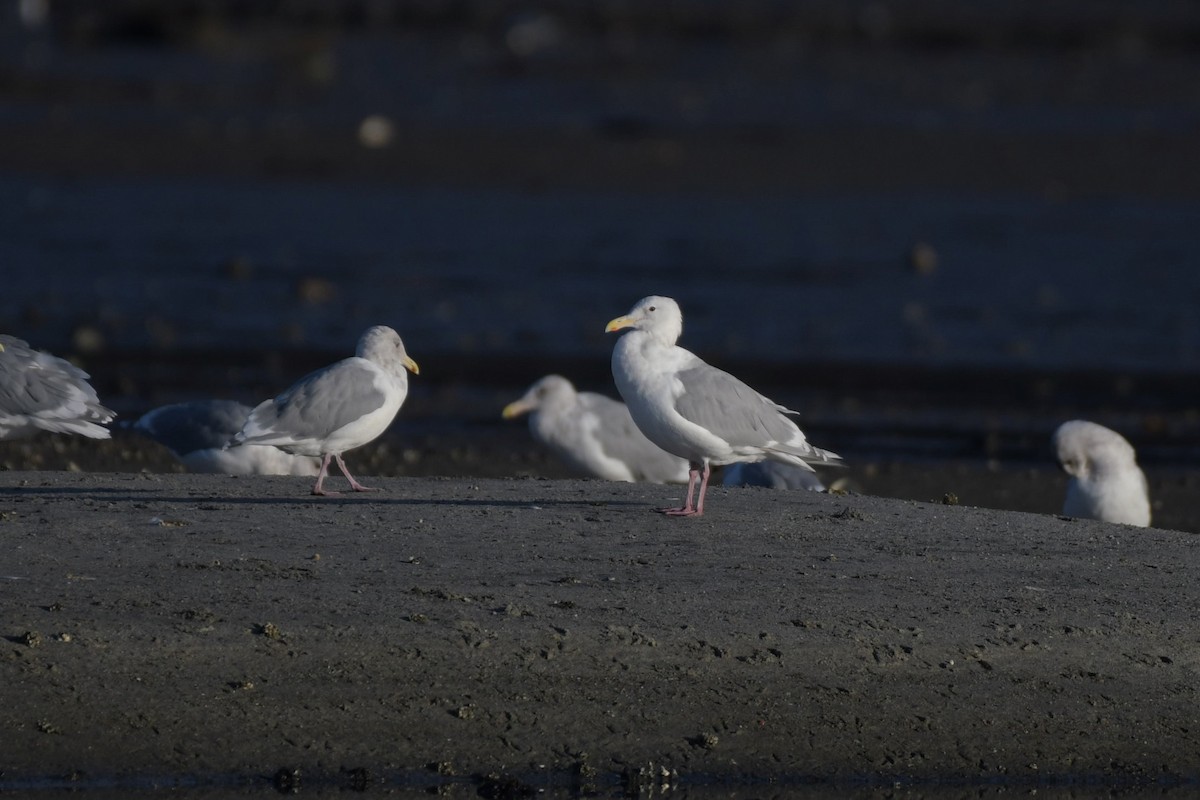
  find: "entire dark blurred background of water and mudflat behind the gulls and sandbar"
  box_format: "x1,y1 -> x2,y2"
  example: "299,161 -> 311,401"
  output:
0,0 -> 1200,529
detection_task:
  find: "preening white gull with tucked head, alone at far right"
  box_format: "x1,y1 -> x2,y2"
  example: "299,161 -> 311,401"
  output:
1054,420 -> 1150,528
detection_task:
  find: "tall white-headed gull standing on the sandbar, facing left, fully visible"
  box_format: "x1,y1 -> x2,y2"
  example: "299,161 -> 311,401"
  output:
605,296 -> 841,516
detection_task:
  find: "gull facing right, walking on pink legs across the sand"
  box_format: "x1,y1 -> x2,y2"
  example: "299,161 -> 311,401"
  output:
232,325 -> 419,494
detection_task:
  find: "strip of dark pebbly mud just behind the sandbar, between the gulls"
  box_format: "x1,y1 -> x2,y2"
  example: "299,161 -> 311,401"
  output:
0,434 -> 1200,534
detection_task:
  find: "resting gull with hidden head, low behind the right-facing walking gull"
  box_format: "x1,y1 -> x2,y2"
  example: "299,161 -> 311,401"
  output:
133,399 -> 320,475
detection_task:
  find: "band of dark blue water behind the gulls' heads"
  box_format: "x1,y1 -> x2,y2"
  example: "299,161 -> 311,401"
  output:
9,175 -> 1200,373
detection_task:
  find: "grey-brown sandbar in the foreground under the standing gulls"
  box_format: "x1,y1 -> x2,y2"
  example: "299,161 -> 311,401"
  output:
0,473 -> 1200,792
